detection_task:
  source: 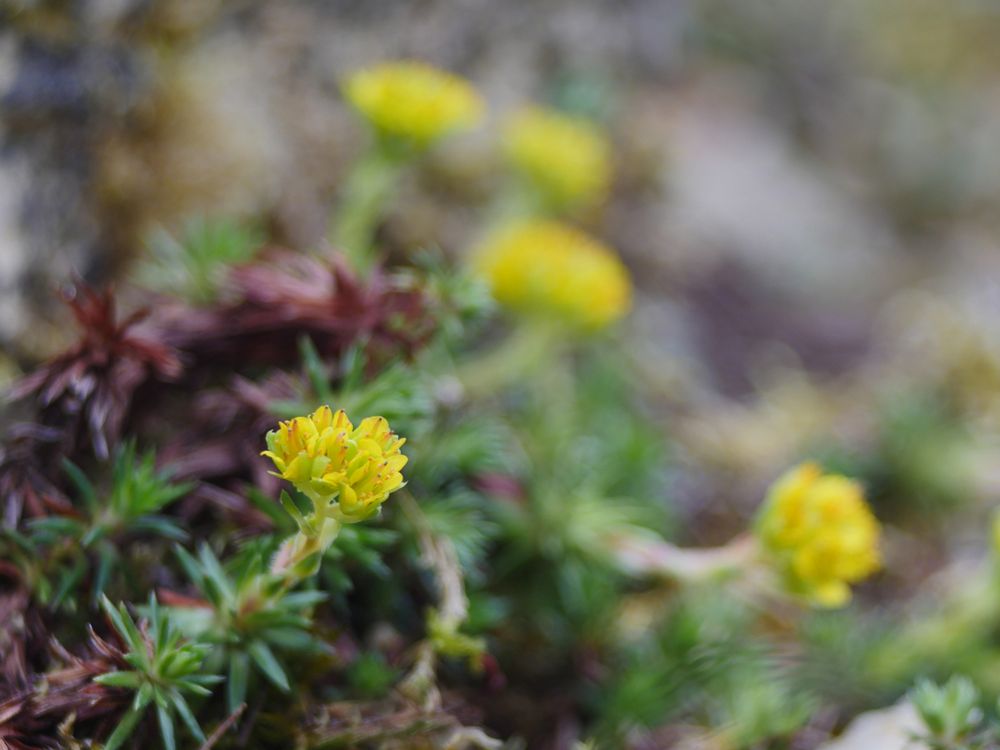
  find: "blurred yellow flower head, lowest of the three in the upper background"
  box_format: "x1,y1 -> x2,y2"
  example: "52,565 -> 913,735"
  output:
475,221 -> 632,328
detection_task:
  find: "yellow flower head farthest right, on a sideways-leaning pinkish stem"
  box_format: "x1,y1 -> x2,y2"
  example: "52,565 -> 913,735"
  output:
757,463 -> 881,607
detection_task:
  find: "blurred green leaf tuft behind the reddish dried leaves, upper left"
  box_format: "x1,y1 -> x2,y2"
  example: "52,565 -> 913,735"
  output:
136,217 -> 262,304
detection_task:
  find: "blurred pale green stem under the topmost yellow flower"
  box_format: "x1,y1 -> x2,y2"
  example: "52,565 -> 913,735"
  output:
331,141 -> 407,273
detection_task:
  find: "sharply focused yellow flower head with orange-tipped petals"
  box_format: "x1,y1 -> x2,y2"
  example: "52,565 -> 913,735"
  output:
261,406 -> 407,523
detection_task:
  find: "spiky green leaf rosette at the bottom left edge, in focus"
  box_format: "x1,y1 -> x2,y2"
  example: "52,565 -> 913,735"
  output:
94,595 -> 221,750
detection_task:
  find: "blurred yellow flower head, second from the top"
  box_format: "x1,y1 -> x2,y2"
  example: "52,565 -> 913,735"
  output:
503,107 -> 611,206
